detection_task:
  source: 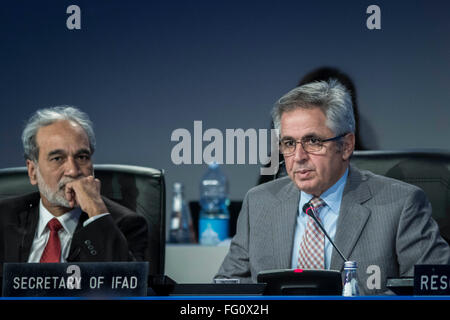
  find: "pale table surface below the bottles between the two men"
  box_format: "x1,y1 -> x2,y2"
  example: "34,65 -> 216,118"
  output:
165,244 -> 229,283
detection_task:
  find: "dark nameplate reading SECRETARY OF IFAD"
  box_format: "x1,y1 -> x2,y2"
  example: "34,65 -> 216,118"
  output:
3,262 -> 148,298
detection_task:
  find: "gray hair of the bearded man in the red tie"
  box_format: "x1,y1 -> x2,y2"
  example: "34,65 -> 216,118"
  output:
22,106 -> 95,162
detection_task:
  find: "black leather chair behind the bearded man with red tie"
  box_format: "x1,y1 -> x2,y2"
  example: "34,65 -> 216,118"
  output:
0,164 -> 166,275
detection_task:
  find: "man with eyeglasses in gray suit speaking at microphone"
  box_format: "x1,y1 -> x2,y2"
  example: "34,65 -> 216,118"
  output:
216,80 -> 450,294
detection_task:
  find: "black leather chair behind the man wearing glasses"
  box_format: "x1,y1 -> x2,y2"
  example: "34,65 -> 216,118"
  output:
351,150 -> 450,243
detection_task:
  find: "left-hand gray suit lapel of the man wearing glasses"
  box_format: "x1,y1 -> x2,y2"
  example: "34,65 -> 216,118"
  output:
273,182 -> 300,269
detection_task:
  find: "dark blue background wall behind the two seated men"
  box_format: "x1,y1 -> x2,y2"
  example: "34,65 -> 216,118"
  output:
0,0 -> 450,209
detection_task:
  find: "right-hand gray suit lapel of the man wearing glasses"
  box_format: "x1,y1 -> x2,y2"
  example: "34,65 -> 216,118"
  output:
330,166 -> 372,270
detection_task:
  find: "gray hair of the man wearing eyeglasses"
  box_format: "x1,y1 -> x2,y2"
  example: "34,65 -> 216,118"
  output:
272,79 -> 355,135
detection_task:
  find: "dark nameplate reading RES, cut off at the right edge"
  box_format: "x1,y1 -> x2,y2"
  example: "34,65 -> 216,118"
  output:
414,265 -> 450,296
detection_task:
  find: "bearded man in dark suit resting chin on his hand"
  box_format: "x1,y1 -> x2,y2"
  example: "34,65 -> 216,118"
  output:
0,106 -> 148,270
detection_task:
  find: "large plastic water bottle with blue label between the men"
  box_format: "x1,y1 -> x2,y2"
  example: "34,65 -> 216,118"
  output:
198,163 -> 230,245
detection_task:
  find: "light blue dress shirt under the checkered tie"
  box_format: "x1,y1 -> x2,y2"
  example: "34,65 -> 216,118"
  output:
291,168 -> 348,269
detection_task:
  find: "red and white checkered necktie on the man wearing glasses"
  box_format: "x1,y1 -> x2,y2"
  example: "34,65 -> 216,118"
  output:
298,197 -> 326,269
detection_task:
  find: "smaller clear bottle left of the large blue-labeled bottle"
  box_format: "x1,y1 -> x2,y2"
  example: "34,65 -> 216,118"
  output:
169,182 -> 196,243
